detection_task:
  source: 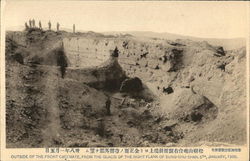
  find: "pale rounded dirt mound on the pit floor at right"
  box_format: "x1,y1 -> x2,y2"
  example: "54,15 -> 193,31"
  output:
161,88 -> 218,123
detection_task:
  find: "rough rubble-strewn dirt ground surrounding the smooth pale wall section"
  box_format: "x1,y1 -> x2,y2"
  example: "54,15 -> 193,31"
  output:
5,29 -> 246,148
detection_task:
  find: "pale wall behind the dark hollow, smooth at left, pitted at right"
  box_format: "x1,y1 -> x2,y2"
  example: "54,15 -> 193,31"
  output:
63,37 -> 189,95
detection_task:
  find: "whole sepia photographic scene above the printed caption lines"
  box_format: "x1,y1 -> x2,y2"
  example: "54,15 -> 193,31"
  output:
1,0 -> 249,148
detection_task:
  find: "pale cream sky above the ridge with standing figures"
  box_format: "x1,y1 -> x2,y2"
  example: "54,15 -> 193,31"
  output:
3,0 -> 248,38
